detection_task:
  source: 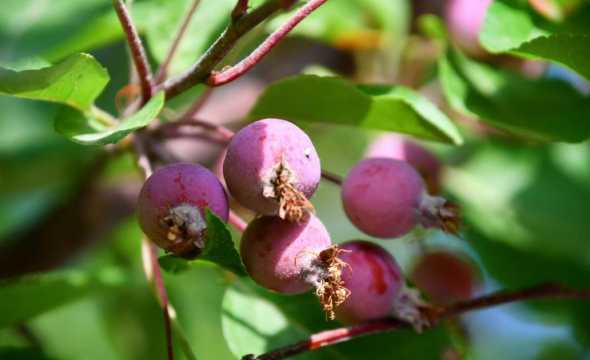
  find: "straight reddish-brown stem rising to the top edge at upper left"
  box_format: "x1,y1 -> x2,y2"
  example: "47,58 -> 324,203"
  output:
113,0 -> 154,103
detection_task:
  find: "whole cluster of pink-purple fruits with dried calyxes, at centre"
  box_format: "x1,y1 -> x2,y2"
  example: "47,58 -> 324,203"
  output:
139,119 -> 480,325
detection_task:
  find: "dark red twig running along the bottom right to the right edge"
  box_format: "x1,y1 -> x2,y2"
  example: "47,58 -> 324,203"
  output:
247,284 -> 590,360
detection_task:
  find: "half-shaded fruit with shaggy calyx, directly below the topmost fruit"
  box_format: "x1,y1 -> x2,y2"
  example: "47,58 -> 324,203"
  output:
240,215 -> 348,317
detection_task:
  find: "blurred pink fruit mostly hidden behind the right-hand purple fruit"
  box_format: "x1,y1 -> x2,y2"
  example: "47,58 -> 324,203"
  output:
367,134 -> 441,194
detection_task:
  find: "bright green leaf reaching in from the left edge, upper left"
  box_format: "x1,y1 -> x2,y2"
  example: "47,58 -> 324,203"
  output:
0,54 -> 109,111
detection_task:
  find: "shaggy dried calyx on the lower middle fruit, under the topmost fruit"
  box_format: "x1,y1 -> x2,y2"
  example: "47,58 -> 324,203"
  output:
301,246 -> 351,320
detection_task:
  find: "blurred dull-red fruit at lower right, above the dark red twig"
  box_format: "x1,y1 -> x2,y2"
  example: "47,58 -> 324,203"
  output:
411,251 -> 477,305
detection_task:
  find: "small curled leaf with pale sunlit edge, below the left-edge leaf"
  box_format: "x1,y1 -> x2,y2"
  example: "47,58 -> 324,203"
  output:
55,92 -> 164,145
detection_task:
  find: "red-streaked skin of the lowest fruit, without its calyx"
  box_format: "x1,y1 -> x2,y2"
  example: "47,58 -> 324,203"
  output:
336,240 -> 404,324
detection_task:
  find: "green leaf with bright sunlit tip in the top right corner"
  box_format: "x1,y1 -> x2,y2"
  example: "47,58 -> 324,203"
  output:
480,0 -> 590,79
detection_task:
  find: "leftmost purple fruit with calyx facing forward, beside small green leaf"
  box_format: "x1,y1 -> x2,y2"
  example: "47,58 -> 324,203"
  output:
138,163 -> 229,258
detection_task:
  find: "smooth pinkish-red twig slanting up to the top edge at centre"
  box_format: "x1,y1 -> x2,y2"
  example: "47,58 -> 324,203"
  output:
207,0 -> 327,86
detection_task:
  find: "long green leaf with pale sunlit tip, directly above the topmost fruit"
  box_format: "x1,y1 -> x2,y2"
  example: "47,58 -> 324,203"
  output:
250,75 -> 463,144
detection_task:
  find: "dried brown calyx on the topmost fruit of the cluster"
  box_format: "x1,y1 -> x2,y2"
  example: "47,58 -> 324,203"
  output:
263,160 -> 314,222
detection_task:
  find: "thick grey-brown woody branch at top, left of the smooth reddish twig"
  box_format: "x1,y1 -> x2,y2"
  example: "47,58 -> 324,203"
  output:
163,0 -> 283,99
